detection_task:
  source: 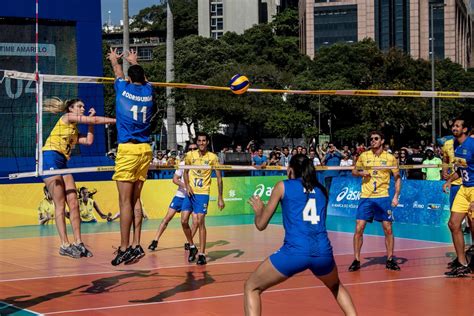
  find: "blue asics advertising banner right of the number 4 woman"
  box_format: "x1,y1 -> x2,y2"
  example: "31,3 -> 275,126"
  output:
328,177 -> 449,226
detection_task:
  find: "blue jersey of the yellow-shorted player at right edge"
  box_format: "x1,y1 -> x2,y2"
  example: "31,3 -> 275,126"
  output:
454,137 -> 474,187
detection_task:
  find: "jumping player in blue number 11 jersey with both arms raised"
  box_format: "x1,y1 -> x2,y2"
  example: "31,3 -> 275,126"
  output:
107,49 -> 153,266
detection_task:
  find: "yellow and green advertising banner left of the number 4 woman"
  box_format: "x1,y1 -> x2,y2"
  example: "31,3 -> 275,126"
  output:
0,176 -> 285,227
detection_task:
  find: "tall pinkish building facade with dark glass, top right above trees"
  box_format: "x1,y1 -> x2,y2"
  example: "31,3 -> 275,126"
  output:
299,0 -> 474,68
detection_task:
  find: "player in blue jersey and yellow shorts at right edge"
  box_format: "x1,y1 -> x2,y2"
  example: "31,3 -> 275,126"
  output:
443,116 -> 474,277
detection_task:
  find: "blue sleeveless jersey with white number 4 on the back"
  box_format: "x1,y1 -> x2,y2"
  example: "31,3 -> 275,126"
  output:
281,179 -> 332,256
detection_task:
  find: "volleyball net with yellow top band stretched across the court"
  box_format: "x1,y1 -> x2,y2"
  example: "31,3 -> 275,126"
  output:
0,70 -> 474,179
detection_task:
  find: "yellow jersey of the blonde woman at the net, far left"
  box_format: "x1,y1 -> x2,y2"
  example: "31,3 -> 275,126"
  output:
43,118 -> 79,159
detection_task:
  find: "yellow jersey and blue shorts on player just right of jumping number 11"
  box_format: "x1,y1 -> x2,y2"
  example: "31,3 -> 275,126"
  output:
182,150 -> 219,214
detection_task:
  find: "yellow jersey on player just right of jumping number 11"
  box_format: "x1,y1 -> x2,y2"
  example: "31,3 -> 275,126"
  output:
184,149 -> 219,194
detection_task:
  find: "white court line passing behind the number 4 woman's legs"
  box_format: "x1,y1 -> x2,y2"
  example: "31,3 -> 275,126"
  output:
0,246 -> 452,283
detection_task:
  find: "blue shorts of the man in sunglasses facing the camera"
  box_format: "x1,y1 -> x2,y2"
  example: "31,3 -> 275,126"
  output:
356,196 -> 393,223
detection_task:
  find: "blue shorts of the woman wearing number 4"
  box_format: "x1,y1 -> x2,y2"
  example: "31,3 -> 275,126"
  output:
269,249 -> 336,278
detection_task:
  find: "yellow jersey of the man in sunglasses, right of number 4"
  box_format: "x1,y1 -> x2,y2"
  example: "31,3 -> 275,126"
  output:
356,150 -> 398,198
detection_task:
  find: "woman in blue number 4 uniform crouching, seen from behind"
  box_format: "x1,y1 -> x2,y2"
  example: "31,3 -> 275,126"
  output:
245,154 -> 356,315
